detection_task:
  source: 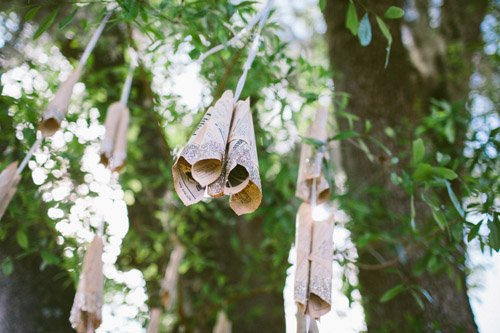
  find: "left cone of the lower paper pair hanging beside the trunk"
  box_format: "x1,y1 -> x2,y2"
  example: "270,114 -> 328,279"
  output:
294,202 -> 313,313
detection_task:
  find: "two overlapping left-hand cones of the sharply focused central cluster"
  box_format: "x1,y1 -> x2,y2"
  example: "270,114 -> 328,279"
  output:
172,90 -> 234,206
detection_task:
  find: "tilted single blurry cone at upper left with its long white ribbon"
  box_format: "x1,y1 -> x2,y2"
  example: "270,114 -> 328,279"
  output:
38,11 -> 112,137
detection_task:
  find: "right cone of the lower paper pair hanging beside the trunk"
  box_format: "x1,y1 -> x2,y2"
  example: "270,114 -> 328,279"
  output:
308,215 -> 333,319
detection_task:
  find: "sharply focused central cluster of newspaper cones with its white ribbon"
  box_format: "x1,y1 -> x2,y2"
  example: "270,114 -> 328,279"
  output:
172,0 -> 273,215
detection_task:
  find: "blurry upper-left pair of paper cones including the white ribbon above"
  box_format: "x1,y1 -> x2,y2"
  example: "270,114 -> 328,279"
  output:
101,50 -> 137,172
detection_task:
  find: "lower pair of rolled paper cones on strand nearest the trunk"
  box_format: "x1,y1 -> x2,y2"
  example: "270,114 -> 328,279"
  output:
294,203 -> 333,319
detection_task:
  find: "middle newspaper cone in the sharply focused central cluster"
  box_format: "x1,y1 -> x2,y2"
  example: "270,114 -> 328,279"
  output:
191,90 -> 234,187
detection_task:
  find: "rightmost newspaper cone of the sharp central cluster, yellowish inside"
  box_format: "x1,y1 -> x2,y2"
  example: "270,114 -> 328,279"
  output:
224,98 -> 262,215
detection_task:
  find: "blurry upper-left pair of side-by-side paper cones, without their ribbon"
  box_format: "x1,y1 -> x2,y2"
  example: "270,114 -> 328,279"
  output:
101,102 -> 130,172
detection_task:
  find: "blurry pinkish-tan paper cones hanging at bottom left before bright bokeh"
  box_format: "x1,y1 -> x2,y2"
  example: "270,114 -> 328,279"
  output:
69,236 -> 104,333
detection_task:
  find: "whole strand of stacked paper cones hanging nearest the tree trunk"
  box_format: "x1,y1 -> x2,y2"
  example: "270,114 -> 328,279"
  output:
294,108 -> 333,333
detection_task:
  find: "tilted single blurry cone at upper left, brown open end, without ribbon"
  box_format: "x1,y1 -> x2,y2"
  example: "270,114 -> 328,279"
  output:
38,68 -> 81,137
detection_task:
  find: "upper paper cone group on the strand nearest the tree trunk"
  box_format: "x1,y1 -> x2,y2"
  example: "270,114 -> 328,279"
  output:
295,108 -> 330,204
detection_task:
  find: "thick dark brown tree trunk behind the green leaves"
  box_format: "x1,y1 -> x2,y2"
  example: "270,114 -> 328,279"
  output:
325,0 -> 487,332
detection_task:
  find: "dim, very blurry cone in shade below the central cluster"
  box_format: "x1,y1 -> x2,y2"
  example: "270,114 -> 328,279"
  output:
160,243 -> 185,309
